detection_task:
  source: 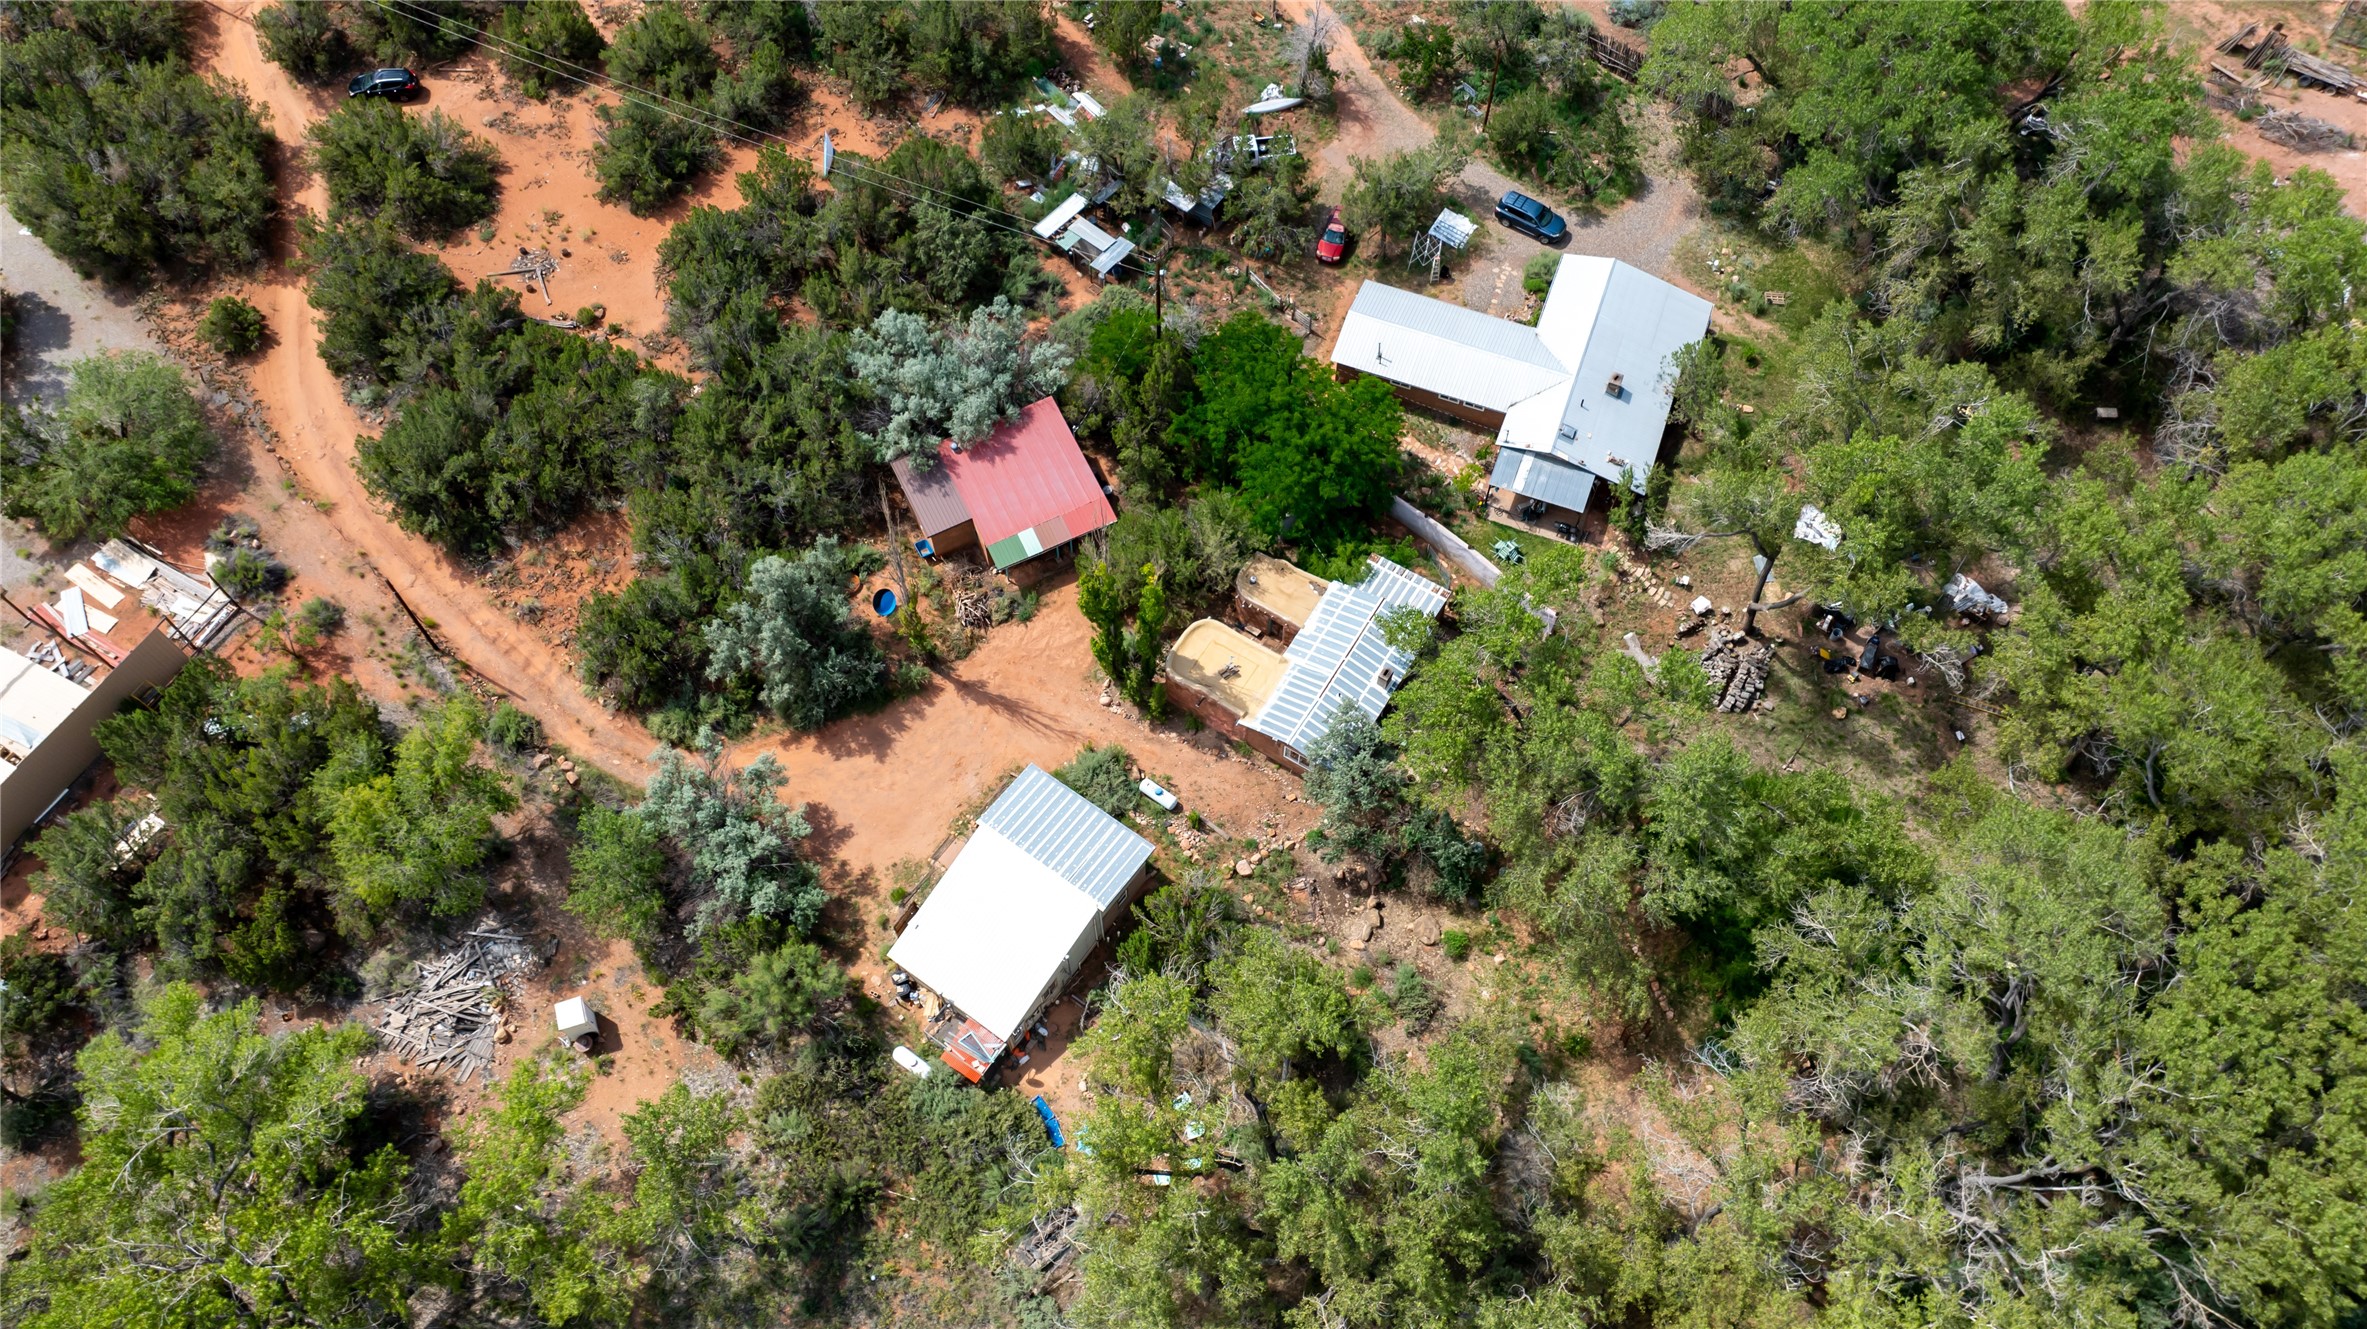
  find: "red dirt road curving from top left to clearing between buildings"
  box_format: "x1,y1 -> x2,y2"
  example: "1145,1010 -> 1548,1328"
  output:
196,2 -> 1295,872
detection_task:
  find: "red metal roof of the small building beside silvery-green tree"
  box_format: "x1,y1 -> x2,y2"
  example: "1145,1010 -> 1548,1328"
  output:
937,398 -> 1117,547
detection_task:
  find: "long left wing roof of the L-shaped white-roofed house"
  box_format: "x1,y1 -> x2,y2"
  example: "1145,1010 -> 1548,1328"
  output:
1333,282 -> 1569,410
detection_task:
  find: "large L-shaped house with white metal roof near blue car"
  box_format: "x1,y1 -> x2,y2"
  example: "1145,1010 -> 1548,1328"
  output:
1333,253 -> 1709,525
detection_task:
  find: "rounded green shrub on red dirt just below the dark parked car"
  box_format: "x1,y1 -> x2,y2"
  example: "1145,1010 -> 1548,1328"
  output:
308,97 -> 499,239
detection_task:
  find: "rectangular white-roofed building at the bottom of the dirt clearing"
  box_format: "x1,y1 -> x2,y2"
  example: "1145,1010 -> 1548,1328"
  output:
888,765 -> 1150,1080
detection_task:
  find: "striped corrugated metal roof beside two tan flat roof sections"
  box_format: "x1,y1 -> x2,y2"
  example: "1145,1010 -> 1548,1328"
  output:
1247,554 -> 1446,751
